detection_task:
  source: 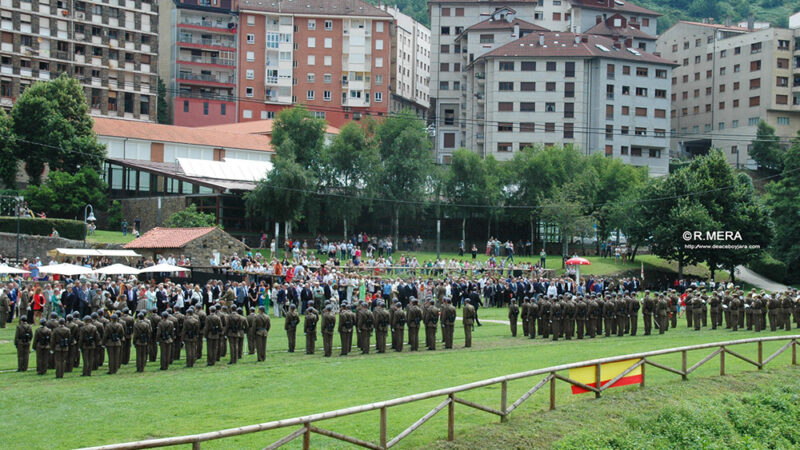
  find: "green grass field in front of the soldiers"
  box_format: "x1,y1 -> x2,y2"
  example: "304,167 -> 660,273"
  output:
0,308 -> 795,449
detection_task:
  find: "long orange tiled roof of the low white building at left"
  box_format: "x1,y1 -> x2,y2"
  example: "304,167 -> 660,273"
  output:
94,117 -> 272,152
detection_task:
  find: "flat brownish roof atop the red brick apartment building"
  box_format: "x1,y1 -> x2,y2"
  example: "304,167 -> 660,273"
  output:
239,0 -> 392,19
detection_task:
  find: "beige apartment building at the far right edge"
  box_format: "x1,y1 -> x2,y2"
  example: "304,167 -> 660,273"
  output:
657,21 -> 800,167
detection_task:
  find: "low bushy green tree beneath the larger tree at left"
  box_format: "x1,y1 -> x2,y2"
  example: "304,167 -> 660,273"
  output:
22,167 -> 108,219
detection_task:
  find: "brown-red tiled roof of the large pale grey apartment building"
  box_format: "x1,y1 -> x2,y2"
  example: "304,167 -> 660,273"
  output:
481,31 -> 675,65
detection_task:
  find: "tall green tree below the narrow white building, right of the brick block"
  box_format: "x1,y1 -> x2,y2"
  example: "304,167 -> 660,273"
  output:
370,109 -> 434,248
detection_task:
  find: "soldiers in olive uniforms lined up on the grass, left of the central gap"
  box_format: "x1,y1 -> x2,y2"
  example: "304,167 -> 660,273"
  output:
14,299 -> 476,378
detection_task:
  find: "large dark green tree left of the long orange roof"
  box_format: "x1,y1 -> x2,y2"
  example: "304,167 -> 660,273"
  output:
11,75 -> 106,184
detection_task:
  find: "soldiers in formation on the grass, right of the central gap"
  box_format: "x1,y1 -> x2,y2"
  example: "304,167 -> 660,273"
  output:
508,290 -> 800,341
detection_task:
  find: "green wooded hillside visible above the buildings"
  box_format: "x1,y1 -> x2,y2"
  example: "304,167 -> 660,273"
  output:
367,0 -> 800,33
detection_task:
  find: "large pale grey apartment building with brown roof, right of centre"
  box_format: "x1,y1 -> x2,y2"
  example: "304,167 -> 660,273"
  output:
462,29 -> 672,176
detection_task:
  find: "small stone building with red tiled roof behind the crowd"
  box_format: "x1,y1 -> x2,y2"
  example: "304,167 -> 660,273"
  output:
125,227 -> 247,268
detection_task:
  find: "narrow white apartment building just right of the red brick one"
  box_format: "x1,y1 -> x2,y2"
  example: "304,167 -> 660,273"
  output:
380,5 -> 431,117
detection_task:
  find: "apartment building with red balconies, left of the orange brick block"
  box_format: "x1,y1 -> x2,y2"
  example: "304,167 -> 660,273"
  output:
158,0 -> 239,126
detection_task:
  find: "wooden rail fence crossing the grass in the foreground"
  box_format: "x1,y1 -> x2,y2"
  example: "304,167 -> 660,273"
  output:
81,335 -> 800,450
